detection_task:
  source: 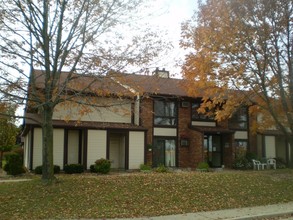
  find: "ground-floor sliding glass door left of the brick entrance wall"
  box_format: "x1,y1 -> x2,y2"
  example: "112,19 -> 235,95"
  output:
153,137 -> 176,167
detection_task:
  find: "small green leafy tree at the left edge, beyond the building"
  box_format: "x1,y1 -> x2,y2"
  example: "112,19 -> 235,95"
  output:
0,103 -> 18,169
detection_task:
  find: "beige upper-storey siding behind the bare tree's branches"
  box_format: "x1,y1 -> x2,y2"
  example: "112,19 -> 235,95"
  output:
53,98 -> 131,123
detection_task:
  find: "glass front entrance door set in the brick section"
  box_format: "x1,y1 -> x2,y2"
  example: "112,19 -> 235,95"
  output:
204,134 -> 223,167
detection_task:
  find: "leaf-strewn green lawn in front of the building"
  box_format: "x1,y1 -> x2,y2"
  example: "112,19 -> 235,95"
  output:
0,169 -> 293,219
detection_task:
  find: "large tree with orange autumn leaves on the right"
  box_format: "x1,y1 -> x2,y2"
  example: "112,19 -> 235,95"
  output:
181,0 -> 293,165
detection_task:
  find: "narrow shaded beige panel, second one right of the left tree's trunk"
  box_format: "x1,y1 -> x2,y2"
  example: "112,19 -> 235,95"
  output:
67,130 -> 79,164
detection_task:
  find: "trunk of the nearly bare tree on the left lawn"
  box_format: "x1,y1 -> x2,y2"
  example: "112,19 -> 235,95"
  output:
42,105 -> 56,184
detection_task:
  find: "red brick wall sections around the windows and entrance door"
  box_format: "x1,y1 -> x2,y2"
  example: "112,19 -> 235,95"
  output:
140,98 -> 234,168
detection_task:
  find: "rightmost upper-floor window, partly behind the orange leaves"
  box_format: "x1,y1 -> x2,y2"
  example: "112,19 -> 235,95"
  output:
229,107 -> 248,130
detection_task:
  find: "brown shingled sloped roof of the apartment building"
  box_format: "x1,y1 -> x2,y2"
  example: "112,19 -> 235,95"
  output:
34,70 -> 194,97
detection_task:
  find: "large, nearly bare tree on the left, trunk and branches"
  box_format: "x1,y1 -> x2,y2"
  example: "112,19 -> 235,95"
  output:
0,0 -> 166,183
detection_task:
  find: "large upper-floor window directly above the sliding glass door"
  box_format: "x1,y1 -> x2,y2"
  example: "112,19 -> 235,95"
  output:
154,100 -> 177,126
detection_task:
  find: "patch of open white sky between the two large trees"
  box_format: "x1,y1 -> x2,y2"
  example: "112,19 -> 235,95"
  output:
147,0 -> 197,75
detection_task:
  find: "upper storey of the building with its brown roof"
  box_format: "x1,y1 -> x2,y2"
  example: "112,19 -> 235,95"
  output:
27,69 -> 249,137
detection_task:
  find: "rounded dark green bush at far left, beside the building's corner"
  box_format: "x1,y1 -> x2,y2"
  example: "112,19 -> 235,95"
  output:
4,152 -> 25,175
